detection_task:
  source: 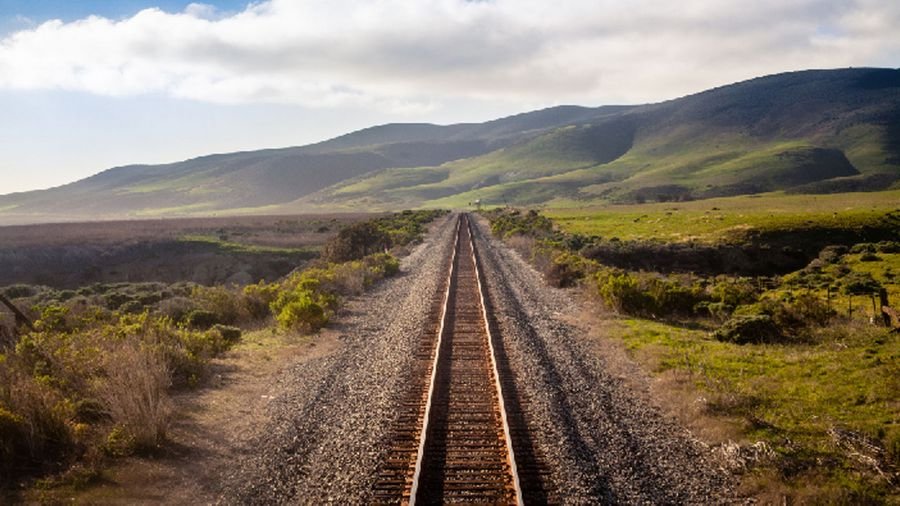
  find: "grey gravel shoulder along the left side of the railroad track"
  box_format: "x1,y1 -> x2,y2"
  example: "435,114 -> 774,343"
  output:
218,212 -> 455,504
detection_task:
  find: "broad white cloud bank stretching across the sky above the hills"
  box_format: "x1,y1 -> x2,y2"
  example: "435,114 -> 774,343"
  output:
0,0 -> 900,106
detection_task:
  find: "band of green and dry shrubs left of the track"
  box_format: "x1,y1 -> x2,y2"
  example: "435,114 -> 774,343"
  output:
0,211 -> 442,492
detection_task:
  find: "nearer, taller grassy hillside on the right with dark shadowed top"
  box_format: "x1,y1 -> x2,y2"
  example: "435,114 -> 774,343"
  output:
310,69 -> 900,207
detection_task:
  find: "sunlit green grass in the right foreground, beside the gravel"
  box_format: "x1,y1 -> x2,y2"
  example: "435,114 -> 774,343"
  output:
620,319 -> 900,503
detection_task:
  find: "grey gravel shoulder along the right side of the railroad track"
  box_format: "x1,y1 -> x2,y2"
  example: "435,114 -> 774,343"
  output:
473,215 -> 733,504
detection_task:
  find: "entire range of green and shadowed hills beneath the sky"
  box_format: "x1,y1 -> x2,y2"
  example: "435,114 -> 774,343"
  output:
0,69 -> 900,221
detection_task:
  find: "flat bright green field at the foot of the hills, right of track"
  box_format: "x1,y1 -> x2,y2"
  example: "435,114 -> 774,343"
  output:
545,190 -> 900,244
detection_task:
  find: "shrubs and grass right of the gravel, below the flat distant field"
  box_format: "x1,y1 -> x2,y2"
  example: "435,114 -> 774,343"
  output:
485,205 -> 900,503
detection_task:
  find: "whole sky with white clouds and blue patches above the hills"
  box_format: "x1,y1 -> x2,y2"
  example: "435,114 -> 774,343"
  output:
0,0 -> 900,194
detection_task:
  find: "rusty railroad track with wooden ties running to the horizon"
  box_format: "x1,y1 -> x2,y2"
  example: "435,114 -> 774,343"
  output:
373,215 -> 547,504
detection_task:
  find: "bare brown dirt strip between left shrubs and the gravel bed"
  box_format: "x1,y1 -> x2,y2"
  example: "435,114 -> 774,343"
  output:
23,330 -> 339,505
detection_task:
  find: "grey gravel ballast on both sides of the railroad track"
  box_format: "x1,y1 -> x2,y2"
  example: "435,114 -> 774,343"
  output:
219,212 -> 732,504
